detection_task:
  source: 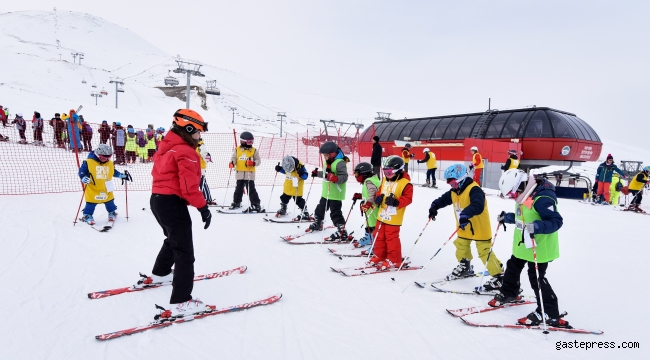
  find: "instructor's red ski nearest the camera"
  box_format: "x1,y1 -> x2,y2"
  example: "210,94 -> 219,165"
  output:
95,294 -> 282,341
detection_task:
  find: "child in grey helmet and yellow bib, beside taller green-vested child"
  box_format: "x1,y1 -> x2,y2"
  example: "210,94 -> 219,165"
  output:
275,155 -> 310,221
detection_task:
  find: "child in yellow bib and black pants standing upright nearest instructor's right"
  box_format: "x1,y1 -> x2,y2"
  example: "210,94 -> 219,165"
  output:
229,131 -> 264,213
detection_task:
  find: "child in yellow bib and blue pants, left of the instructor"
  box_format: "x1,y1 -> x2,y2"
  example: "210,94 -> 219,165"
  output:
79,144 -> 132,225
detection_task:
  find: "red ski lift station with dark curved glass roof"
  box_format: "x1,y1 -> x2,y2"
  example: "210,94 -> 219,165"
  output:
359,106 -> 603,195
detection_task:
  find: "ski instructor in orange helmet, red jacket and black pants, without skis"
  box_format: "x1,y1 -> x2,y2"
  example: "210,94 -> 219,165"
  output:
146,109 -> 211,317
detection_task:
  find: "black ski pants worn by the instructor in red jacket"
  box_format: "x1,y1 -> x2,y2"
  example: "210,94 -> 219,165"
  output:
149,194 -> 194,304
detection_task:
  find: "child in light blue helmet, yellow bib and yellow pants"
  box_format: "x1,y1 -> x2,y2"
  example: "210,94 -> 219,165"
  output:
429,164 -> 503,291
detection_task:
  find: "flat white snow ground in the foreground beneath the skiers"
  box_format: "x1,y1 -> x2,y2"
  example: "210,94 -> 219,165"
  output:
0,184 -> 650,359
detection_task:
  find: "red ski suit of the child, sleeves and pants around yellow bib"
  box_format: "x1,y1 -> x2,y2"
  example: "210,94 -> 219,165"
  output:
373,173 -> 413,266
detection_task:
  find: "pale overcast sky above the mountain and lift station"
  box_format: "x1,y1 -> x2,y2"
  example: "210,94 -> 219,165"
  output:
0,0 -> 650,143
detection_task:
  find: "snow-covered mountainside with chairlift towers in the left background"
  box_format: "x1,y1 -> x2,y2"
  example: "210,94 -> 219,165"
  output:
0,11 -> 382,134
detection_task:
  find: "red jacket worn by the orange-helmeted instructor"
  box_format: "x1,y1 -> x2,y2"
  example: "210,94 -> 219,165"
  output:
151,131 -> 207,209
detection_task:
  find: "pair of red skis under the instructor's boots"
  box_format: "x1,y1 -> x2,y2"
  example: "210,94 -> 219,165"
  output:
88,265 -> 282,341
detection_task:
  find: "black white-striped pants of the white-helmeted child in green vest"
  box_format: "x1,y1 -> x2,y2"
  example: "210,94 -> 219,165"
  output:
501,255 -> 560,319
